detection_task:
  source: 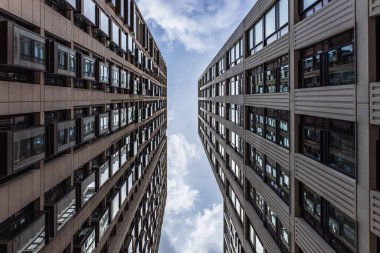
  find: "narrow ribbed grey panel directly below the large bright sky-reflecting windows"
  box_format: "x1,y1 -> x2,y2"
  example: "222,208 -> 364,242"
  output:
244,34 -> 289,70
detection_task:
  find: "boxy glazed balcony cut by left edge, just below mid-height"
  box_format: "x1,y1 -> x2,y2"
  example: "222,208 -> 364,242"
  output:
0,127 -> 45,176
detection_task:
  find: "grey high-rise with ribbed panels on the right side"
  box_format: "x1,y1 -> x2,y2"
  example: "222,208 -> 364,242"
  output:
198,0 -> 380,253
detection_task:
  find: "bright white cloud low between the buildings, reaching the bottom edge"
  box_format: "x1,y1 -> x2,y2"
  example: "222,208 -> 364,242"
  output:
160,134 -> 223,253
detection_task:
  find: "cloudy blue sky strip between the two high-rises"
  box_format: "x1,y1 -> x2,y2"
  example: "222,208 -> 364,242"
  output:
138,0 -> 255,253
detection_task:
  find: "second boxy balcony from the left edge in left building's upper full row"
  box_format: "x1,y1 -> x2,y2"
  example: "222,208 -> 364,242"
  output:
47,41 -> 77,77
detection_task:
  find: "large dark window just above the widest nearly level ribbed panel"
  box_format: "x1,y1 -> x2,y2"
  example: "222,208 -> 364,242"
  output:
301,31 -> 356,88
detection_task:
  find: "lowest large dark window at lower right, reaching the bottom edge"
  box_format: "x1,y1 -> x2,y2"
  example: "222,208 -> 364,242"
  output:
301,184 -> 356,252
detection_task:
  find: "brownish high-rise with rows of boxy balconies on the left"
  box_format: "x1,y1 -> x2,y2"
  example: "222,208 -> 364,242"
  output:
0,0 -> 167,253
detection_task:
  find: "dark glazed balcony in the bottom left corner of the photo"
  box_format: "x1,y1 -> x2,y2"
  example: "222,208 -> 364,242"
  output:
0,210 -> 45,253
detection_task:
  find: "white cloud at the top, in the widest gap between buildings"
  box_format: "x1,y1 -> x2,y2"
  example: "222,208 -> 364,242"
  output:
138,0 -> 252,52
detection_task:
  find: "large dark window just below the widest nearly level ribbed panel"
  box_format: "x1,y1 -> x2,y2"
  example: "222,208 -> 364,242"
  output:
301,116 -> 356,178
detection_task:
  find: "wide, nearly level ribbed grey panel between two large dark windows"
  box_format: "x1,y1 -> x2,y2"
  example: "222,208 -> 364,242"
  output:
294,84 -> 356,121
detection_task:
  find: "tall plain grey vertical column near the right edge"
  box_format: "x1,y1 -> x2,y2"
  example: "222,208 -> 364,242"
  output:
355,1 -> 379,253
